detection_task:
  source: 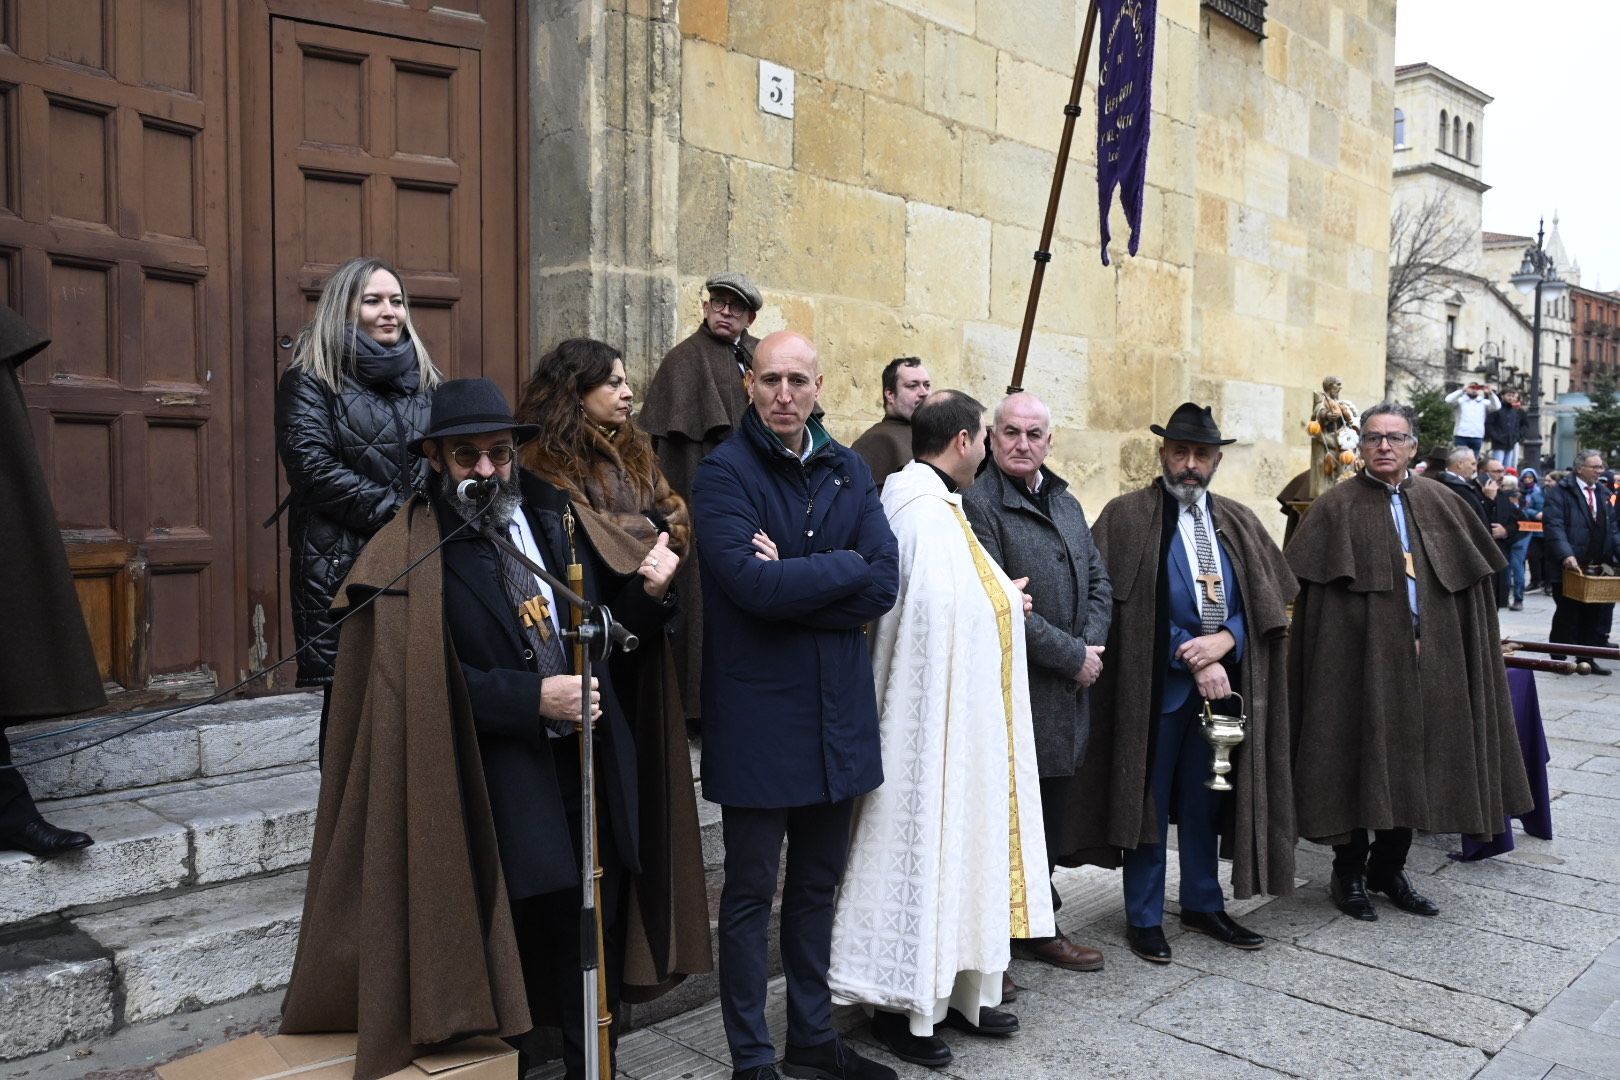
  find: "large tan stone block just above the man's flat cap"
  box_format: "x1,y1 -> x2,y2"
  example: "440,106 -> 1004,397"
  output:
727,160 -> 906,306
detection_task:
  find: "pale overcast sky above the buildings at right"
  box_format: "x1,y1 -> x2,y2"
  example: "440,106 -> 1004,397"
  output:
1395,0 -> 1620,290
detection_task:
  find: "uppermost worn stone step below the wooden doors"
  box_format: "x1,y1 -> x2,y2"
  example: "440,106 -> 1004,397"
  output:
11,693 -> 321,800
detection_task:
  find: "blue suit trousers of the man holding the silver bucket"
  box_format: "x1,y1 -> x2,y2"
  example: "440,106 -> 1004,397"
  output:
1124,695 -> 1226,926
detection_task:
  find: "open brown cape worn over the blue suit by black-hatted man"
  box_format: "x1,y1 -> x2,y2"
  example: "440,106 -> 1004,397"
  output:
1056,481 -> 1298,899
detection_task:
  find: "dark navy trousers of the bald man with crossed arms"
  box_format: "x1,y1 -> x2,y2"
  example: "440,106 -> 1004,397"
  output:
719,800 -> 855,1070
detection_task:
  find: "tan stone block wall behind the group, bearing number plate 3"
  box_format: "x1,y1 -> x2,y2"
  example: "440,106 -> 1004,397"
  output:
583,0 -> 1395,526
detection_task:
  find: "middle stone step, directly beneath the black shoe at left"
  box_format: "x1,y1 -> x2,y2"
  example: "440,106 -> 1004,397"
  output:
0,764 -> 321,926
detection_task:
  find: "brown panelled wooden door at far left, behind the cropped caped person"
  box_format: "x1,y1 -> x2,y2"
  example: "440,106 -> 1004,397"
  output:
0,0 -> 238,688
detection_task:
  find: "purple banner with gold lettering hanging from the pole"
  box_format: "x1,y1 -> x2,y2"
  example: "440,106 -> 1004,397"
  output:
1097,0 -> 1158,266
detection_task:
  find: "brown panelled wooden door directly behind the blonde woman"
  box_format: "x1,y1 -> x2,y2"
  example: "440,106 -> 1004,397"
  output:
238,0 -> 528,685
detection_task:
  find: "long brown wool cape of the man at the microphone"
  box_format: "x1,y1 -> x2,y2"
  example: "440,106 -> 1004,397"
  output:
282,495 -> 531,1080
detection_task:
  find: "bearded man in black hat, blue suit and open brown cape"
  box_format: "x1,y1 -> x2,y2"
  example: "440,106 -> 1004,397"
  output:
1064,402 -> 1294,963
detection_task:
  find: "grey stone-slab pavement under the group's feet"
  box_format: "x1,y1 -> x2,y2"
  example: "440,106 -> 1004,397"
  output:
15,596 -> 1620,1080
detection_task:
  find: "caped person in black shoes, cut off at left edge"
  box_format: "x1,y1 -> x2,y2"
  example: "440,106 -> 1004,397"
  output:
0,304 -> 107,858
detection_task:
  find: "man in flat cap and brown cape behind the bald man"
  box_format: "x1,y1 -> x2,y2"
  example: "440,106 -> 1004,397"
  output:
637,270 -> 765,721
